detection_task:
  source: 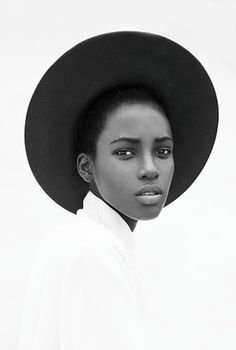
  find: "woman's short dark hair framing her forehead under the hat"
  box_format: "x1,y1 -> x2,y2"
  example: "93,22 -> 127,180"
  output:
75,85 -> 167,160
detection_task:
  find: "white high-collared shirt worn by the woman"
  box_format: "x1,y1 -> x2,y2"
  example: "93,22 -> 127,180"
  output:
19,192 -> 149,350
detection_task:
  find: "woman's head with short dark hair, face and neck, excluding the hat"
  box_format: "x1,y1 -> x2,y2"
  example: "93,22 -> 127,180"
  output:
77,86 -> 174,231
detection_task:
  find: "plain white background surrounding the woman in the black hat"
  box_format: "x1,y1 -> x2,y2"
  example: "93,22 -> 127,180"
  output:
0,0 -> 236,350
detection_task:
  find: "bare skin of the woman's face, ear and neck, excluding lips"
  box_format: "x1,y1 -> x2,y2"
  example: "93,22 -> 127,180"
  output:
77,103 -> 174,231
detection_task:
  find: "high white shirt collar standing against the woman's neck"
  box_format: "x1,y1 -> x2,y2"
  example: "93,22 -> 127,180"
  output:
77,191 -> 135,251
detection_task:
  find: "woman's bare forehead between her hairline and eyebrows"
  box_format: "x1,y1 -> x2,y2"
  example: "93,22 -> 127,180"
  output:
101,103 -> 172,139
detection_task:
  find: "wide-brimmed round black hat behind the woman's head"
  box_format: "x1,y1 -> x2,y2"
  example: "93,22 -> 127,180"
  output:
25,31 -> 218,213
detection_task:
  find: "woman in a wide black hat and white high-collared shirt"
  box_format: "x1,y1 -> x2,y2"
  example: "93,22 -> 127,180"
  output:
21,32 -> 218,350
